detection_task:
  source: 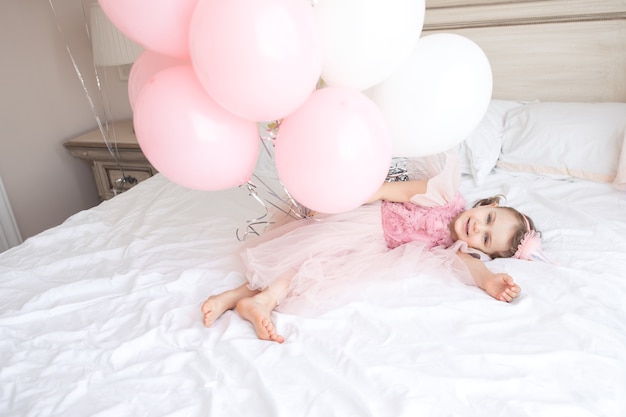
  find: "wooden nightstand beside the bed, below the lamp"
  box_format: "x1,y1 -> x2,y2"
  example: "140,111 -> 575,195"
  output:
63,120 -> 157,200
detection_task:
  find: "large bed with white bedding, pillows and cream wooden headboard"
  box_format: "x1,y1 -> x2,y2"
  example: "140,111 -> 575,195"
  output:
0,0 -> 626,417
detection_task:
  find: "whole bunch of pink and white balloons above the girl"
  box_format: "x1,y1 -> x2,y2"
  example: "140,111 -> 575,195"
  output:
99,0 -> 491,213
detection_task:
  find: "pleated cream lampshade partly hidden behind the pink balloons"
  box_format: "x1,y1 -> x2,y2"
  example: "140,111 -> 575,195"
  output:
90,3 -> 143,66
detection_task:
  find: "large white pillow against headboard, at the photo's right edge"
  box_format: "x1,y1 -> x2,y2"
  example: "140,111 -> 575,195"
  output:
497,102 -> 626,182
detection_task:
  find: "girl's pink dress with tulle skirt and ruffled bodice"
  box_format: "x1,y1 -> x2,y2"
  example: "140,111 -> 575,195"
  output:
241,154 -> 471,311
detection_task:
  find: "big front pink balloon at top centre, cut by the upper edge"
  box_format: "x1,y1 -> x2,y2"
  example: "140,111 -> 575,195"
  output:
190,0 -> 322,121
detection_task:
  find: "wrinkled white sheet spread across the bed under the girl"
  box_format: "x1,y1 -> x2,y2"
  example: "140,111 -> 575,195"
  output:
0,171 -> 626,417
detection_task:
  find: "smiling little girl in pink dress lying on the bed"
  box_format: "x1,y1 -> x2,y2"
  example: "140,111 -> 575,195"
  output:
202,153 -> 539,343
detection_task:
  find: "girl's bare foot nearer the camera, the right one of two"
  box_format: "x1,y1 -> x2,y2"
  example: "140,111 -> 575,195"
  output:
237,292 -> 285,343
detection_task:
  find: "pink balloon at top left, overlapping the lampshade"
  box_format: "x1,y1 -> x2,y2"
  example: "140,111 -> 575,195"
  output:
99,0 -> 198,58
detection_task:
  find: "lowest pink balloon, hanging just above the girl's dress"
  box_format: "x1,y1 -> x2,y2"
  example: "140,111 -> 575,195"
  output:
275,87 -> 391,213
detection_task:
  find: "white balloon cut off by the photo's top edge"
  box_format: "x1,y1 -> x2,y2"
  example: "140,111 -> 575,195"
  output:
314,0 -> 425,91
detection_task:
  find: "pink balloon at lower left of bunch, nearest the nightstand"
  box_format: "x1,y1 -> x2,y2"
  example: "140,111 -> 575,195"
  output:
134,66 -> 260,190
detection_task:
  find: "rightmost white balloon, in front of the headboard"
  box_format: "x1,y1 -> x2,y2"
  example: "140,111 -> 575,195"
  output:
365,33 -> 493,157
